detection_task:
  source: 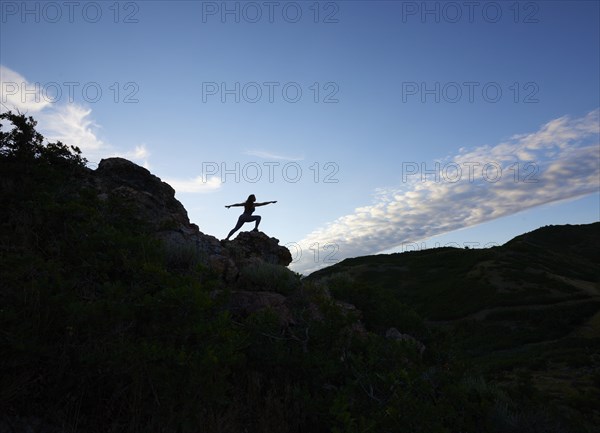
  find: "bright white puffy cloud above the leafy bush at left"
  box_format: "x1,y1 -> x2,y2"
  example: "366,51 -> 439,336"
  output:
0,65 -> 150,168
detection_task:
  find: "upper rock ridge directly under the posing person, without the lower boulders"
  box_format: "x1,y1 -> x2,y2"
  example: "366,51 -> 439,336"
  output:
90,158 -> 292,282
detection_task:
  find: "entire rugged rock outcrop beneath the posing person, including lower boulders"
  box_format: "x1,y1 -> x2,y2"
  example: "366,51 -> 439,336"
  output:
88,158 -> 362,329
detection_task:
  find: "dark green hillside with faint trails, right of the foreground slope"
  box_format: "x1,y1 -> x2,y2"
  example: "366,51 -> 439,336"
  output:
307,223 -> 600,425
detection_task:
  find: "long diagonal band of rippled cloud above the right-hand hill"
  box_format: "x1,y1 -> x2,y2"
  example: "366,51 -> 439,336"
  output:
292,109 -> 600,273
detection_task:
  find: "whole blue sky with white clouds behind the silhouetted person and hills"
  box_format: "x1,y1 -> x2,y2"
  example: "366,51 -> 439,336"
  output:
0,0 -> 600,274
